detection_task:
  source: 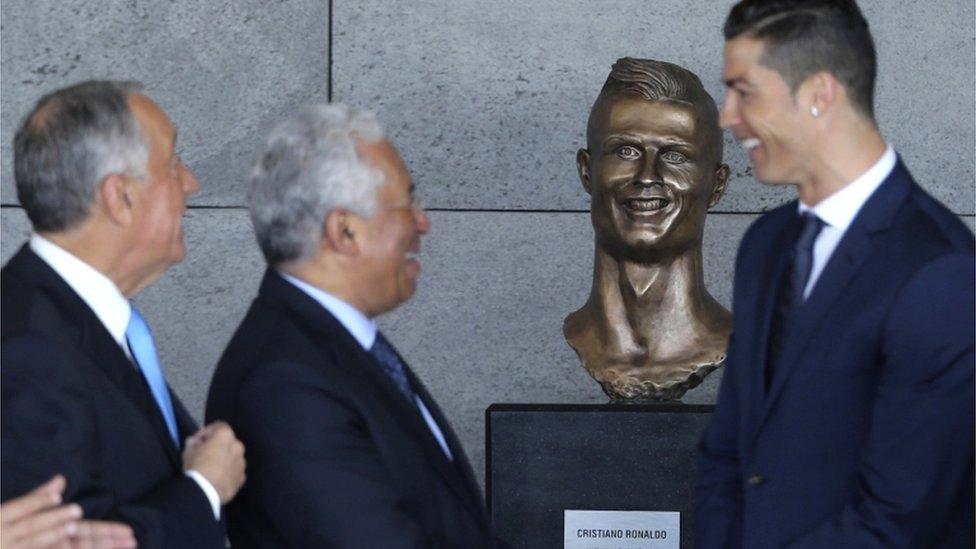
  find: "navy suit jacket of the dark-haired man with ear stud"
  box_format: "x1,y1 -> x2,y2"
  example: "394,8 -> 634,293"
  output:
696,160 -> 976,549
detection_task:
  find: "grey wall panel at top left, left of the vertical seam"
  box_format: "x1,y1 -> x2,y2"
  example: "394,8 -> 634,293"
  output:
0,0 -> 329,206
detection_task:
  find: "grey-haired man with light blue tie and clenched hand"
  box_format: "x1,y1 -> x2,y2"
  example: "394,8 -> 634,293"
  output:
0,82 -> 244,548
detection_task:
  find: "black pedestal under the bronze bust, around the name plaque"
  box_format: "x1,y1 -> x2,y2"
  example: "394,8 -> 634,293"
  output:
485,403 -> 713,549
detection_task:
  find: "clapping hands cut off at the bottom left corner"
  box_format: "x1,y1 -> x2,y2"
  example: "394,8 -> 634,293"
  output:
0,475 -> 136,549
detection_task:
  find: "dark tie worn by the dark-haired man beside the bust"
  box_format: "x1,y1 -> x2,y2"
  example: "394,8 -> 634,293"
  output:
766,211 -> 823,391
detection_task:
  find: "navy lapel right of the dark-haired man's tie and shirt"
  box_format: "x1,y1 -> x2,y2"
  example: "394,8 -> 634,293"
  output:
764,159 -> 912,417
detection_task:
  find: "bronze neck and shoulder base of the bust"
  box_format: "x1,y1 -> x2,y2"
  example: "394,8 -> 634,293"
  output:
564,246 -> 732,396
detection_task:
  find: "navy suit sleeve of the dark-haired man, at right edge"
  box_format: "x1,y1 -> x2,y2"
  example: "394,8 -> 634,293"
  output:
791,255 -> 976,548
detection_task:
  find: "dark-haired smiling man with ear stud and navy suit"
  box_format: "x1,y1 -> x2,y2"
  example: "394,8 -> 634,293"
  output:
696,0 -> 976,548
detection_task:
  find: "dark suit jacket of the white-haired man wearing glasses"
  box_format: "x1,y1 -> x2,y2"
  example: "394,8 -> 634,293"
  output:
207,271 -> 489,548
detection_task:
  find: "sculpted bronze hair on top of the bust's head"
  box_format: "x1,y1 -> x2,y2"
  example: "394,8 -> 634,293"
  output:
587,57 -> 722,163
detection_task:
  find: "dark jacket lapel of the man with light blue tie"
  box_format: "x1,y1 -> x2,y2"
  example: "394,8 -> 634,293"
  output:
8,245 -> 181,468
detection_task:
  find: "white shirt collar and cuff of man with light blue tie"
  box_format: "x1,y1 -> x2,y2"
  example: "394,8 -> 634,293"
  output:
29,234 -> 220,520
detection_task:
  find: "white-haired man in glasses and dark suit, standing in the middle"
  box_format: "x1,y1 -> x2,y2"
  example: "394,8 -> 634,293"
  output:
207,105 -> 491,548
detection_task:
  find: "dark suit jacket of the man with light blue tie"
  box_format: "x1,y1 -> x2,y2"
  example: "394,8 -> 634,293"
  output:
0,246 -> 224,549
